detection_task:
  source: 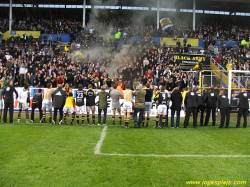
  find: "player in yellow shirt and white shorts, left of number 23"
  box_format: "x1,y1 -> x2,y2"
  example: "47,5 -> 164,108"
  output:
63,92 -> 75,125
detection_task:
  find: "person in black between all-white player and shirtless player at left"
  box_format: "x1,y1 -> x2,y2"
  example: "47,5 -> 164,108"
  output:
31,89 -> 43,123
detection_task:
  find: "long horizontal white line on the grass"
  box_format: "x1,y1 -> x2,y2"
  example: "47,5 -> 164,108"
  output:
95,153 -> 250,158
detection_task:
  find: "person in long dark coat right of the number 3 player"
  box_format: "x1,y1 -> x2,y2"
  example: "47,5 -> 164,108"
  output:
170,87 -> 183,128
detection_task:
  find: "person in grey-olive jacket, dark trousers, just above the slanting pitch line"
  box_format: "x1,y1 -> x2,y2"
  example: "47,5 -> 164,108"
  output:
97,85 -> 109,125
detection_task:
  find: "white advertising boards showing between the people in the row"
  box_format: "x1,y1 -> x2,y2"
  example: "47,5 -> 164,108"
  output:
9,87 -> 185,117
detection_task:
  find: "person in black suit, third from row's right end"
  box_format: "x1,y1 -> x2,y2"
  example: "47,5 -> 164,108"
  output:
204,88 -> 217,126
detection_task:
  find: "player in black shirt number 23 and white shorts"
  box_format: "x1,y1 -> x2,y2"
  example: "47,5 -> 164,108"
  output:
76,84 -> 85,125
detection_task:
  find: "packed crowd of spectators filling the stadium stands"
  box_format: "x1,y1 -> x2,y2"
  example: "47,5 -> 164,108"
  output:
0,12 -> 250,91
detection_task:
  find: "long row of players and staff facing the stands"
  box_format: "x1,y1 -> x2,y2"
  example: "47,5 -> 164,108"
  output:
0,80 -> 250,128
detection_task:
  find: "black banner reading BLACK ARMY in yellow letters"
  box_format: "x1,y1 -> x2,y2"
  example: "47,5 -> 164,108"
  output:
169,53 -> 210,65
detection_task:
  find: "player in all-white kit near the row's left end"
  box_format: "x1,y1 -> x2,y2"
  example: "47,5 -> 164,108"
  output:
18,85 -> 30,123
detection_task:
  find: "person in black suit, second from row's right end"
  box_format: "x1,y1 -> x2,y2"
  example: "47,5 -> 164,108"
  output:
218,91 -> 231,128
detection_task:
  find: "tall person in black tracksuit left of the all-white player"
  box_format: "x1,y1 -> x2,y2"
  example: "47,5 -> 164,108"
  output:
3,80 -> 18,123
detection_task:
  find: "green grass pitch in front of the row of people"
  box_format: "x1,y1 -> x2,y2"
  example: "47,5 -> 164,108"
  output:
0,114 -> 250,187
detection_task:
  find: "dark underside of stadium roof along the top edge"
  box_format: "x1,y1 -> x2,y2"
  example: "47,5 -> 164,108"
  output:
0,0 -> 250,12
